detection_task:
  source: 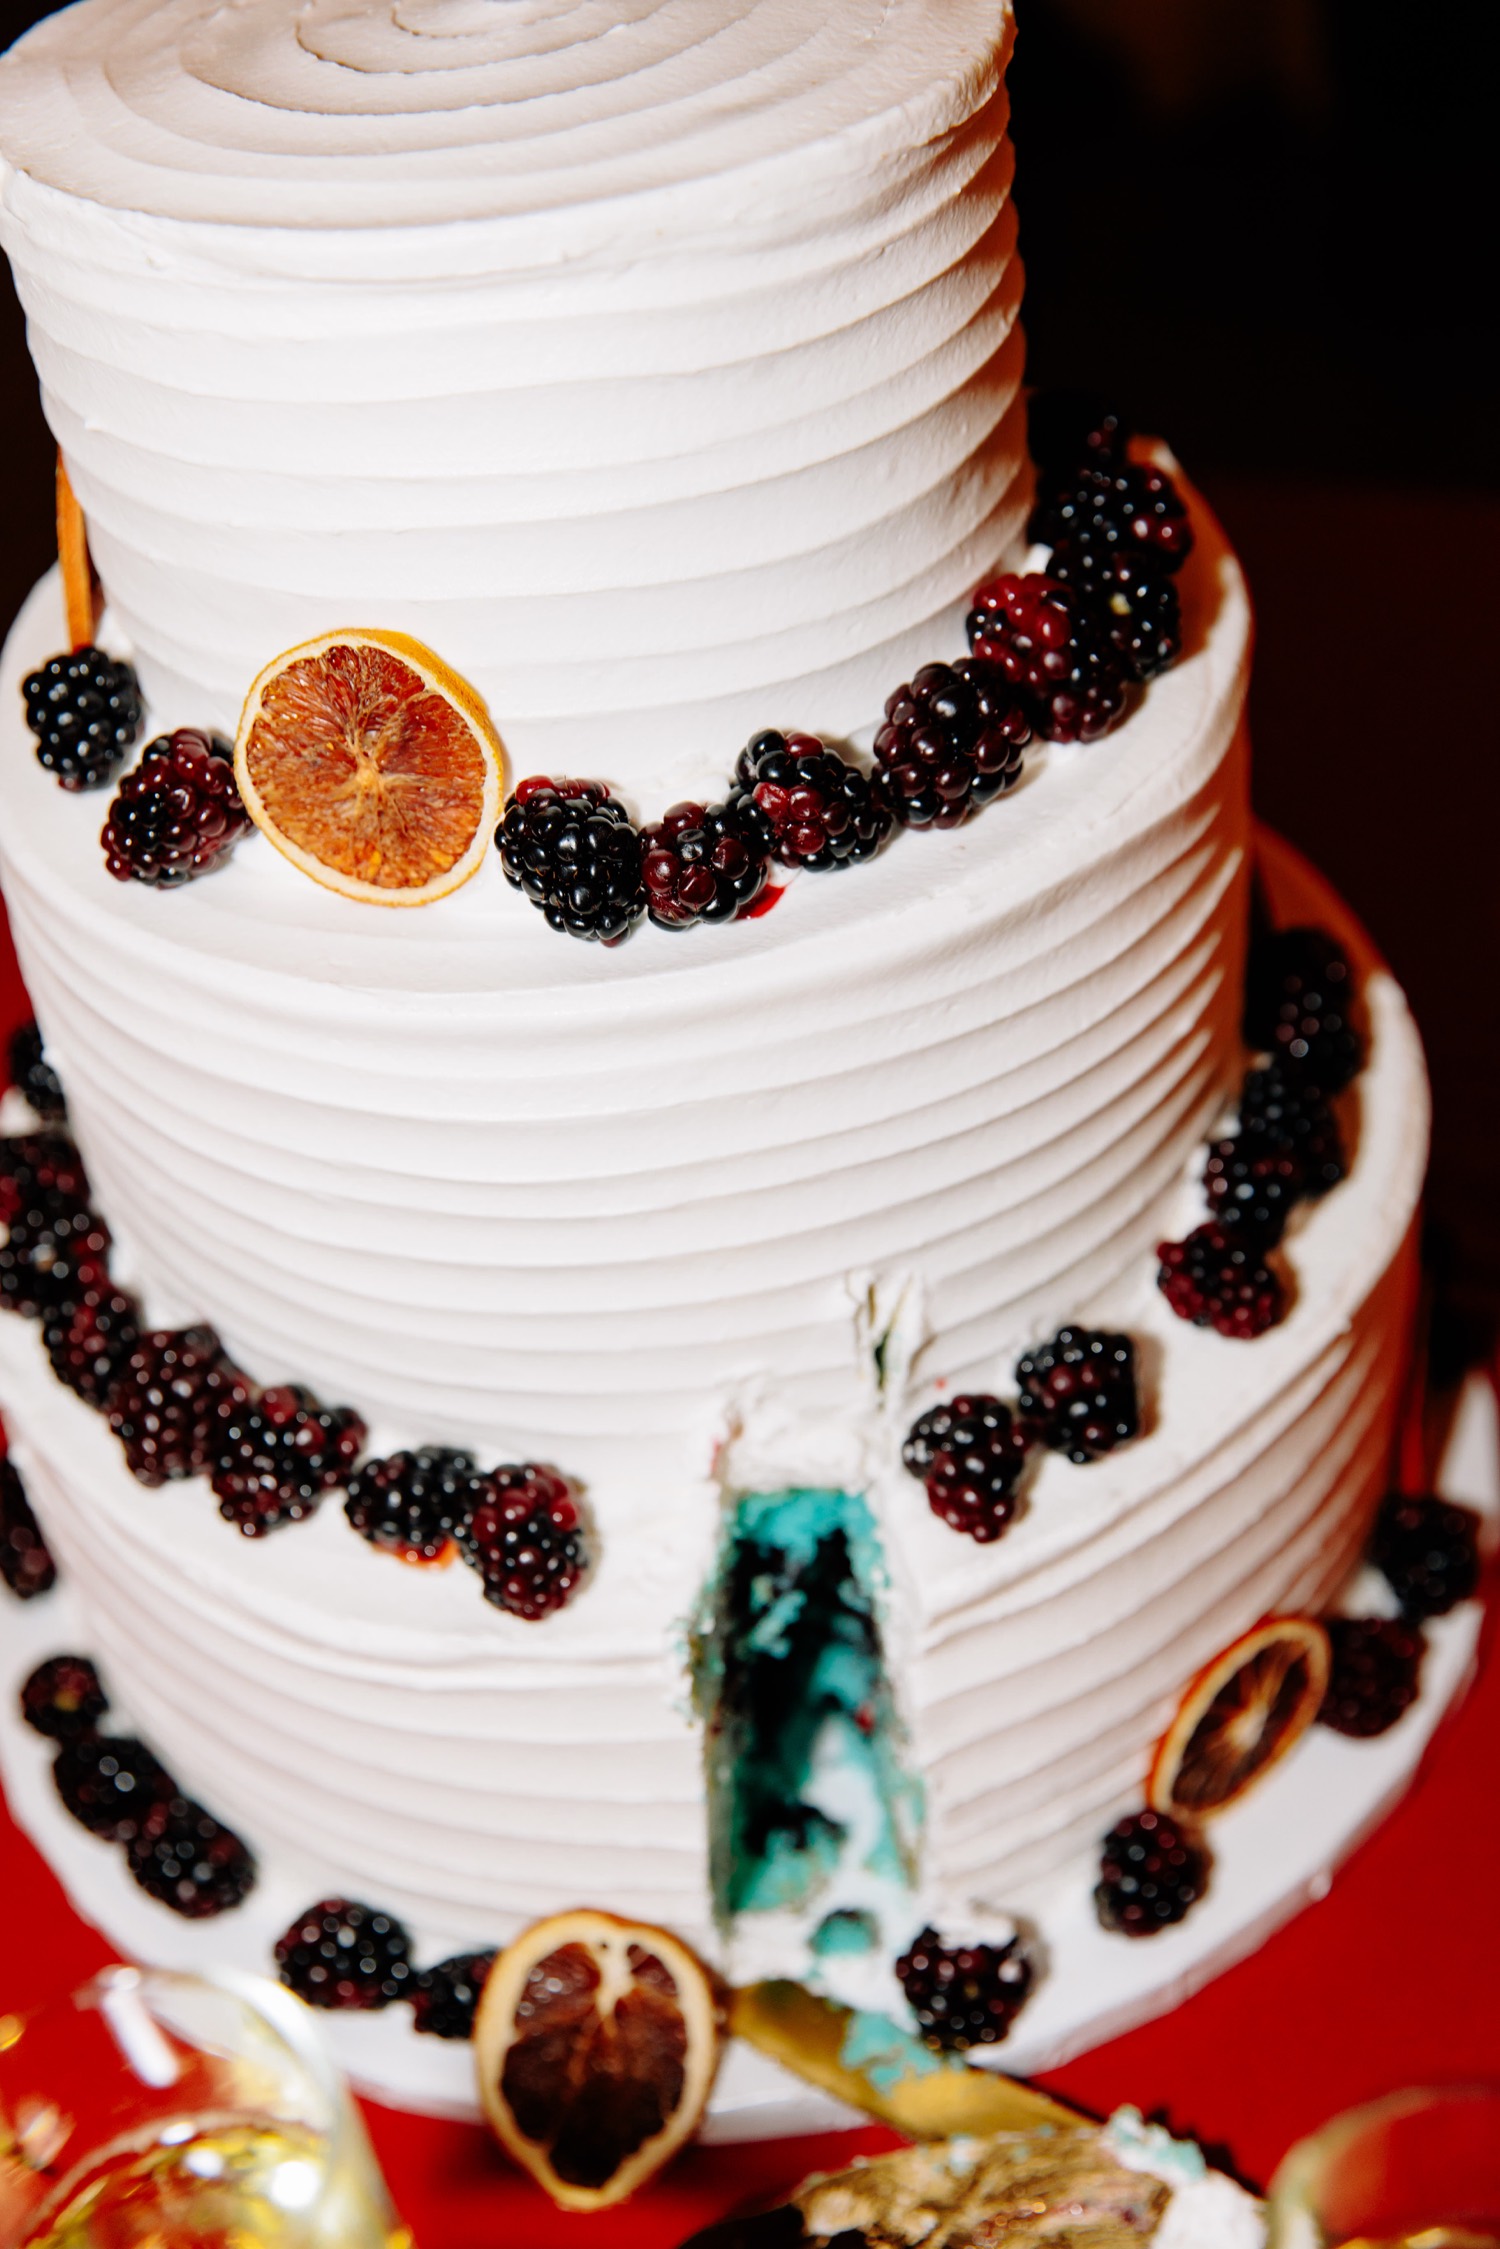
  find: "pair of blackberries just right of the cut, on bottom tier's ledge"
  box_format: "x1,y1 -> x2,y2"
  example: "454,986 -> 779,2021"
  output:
902,1327 -> 1140,1545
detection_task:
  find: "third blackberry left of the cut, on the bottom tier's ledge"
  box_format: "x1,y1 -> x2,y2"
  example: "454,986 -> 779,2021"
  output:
209,1383 -> 364,1538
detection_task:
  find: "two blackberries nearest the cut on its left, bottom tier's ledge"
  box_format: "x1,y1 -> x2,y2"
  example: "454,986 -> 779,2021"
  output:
344,1446 -> 589,1622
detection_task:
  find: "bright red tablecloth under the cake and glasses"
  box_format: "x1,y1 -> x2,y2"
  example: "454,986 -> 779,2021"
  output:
0,899 -> 1500,2249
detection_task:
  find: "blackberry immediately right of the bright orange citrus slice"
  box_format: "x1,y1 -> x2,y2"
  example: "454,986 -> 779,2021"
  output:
495,774 -> 645,945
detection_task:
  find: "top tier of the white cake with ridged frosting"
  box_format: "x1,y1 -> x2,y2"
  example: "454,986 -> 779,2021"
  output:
0,0 -> 1023,816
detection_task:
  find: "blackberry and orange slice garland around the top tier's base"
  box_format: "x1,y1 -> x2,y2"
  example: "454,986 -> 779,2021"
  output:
22,391 -> 1192,917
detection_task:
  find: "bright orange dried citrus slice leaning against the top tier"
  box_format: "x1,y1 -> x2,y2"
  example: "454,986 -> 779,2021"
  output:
234,632 -> 501,906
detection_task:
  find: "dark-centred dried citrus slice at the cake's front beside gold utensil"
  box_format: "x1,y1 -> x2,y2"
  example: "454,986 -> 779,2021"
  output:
475,1909 -> 722,2211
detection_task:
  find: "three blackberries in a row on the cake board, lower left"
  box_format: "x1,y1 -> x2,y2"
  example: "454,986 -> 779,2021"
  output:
20,1655 -> 256,1921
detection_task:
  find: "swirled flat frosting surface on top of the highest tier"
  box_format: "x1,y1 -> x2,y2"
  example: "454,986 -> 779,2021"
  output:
0,0 -> 1010,229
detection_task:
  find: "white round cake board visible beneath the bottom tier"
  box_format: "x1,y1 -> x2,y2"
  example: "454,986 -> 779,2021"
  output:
0,1376 -> 1500,2141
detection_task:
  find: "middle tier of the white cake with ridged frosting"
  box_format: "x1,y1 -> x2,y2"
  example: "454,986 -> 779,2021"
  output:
0,511 -> 1248,1489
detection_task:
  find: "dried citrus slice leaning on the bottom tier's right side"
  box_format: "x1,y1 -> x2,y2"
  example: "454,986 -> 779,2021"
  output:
1147,1617 -> 1329,1819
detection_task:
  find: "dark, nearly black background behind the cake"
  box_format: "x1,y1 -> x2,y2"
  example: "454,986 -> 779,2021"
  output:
0,0 -> 1500,1345
